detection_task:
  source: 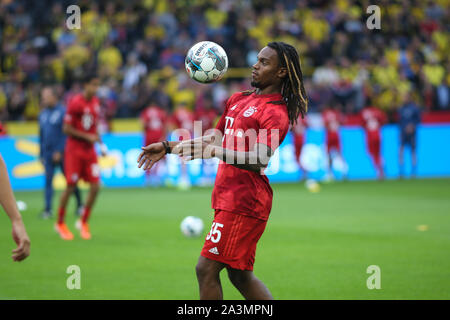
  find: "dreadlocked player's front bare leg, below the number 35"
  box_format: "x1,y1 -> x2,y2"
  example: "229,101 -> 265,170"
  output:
195,256 -> 225,300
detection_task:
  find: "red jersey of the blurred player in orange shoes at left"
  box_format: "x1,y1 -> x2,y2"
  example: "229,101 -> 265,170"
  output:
64,94 -> 100,150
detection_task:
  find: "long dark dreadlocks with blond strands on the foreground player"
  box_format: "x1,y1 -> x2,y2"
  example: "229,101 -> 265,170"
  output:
267,42 -> 308,125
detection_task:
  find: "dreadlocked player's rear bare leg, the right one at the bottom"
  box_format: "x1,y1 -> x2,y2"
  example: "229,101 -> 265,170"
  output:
227,268 -> 273,300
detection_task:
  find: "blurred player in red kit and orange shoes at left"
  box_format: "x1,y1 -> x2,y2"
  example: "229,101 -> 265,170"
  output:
55,75 -> 105,240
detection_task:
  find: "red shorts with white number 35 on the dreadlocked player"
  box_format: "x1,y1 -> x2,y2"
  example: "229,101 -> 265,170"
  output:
201,210 -> 267,271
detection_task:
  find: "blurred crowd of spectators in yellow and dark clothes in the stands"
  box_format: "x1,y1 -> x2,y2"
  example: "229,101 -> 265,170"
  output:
0,0 -> 450,127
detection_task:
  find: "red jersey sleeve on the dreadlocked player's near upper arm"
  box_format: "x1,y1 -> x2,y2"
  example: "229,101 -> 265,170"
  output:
256,106 -> 289,152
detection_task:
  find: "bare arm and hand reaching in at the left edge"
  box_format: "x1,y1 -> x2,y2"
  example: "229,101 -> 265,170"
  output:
0,154 -> 30,261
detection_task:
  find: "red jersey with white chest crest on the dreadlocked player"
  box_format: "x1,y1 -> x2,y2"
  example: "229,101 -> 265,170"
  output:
212,93 -> 289,220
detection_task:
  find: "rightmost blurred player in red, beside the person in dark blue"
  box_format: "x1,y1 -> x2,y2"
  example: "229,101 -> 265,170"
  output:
361,106 -> 387,180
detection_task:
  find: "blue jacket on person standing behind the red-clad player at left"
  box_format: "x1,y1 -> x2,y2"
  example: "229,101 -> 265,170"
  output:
39,104 -> 66,158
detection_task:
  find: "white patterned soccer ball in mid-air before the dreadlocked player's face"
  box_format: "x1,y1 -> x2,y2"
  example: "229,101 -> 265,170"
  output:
185,41 -> 228,83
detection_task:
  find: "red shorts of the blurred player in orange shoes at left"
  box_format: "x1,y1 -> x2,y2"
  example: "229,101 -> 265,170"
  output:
64,149 -> 100,185
